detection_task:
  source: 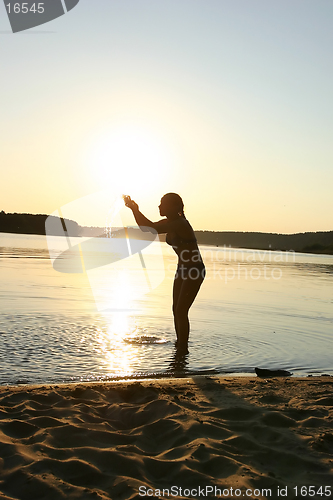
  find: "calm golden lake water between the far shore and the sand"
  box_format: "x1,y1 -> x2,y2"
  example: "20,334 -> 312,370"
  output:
0,233 -> 333,384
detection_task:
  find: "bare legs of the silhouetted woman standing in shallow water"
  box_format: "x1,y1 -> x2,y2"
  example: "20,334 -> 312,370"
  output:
173,273 -> 204,350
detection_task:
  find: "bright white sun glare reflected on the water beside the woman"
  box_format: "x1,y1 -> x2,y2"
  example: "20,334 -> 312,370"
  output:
86,248 -> 167,376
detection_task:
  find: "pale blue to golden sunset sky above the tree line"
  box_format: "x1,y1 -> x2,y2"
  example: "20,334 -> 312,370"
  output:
0,0 -> 333,233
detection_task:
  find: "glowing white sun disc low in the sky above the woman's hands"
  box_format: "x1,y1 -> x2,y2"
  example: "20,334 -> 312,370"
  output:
90,125 -> 174,196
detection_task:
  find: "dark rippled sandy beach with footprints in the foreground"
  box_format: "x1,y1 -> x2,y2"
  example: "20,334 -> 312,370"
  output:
0,376 -> 333,500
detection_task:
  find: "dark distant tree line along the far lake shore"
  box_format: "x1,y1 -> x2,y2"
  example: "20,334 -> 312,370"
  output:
0,211 -> 333,255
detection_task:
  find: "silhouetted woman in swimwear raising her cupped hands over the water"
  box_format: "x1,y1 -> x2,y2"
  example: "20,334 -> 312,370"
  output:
123,193 -> 206,353
